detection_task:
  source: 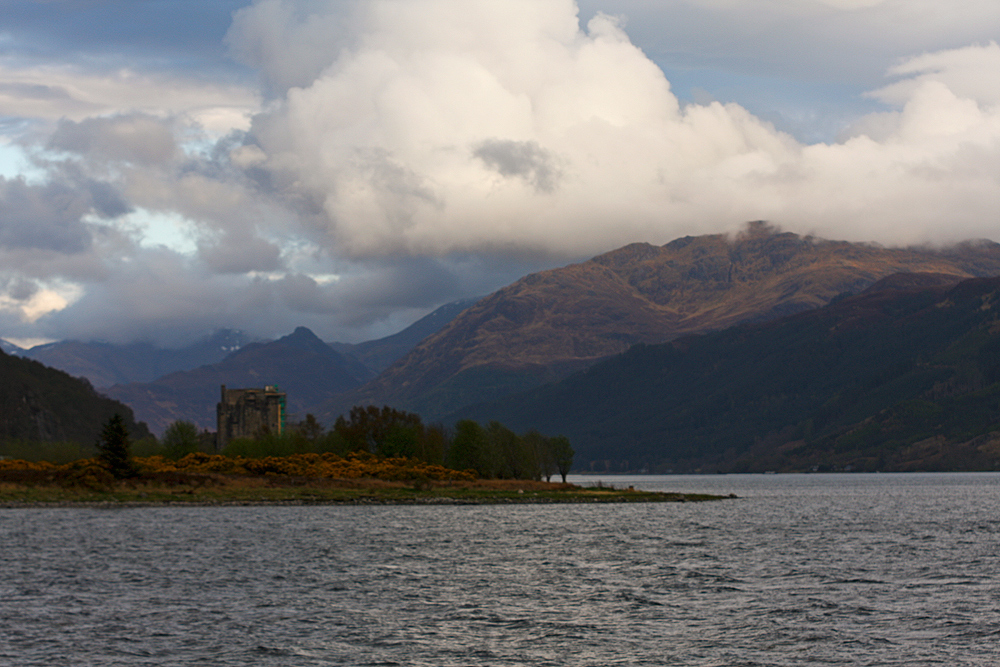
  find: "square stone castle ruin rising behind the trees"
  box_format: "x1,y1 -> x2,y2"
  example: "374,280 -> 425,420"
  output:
215,385 -> 286,451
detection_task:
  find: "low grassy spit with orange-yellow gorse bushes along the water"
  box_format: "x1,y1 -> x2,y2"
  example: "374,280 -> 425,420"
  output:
0,464 -> 726,509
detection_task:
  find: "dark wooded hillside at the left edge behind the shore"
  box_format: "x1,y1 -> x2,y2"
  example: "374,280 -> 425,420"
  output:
0,352 -> 149,447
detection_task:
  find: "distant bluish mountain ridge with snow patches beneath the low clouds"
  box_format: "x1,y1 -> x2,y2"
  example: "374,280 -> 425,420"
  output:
20,329 -> 260,387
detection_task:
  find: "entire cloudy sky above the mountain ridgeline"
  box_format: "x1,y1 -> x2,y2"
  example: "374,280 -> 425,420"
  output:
0,0 -> 1000,346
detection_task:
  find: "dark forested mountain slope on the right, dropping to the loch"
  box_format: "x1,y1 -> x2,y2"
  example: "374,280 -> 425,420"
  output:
456,274 -> 1000,472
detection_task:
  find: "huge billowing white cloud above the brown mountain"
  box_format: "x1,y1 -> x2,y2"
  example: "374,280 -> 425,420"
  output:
229,0 -> 1000,256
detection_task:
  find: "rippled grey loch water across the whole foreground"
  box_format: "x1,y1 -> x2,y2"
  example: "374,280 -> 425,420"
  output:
0,473 -> 1000,667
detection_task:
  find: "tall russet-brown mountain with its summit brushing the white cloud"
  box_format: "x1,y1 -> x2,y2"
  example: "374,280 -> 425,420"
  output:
320,223 -> 1000,421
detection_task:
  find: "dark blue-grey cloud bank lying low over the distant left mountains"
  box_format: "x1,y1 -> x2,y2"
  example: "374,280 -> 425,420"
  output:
27,247 -> 476,345
